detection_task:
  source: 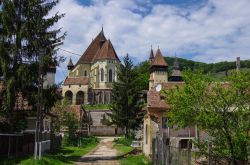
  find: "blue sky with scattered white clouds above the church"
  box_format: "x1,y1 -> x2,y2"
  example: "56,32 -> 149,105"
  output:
52,0 -> 250,82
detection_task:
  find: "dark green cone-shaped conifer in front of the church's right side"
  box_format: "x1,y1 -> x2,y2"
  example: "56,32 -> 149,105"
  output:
108,55 -> 143,137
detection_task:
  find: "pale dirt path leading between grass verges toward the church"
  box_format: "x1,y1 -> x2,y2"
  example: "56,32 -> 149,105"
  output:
75,137 -> 120,165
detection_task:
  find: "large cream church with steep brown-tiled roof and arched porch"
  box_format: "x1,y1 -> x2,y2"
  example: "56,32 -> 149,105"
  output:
62,29 -> 120,105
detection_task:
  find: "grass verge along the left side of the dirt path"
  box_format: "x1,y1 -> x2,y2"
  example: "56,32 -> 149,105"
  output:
0,137 -> 98,165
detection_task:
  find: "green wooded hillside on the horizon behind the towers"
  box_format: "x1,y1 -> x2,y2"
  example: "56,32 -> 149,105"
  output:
136,57 -> 250,90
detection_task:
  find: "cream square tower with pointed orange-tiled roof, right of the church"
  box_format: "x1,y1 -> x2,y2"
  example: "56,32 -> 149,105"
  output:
149,48 -> 168,90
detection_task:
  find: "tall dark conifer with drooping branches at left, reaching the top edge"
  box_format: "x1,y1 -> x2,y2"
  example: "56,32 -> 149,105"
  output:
0,0 -> 65,132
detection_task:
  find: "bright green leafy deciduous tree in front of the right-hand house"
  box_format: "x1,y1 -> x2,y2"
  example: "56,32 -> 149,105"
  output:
165,71 -> 250,165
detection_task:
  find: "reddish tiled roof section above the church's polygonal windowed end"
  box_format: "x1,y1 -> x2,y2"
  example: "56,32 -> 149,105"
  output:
93,40 -> 119,60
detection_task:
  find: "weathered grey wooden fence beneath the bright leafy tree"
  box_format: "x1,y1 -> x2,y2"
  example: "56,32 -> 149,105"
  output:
152,135 -> 250,165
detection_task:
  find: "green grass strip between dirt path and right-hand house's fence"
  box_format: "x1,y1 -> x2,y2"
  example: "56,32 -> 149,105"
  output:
114,138 -> 152,165
